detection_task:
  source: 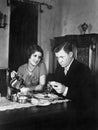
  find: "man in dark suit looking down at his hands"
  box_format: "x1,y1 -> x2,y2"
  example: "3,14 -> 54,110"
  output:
49,42 -> 95,116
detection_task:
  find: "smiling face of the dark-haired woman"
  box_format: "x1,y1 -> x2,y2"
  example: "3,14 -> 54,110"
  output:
29,51 -> 42,66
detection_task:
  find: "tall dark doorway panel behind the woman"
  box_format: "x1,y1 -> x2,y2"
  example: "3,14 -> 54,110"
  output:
9,2 -> 38,71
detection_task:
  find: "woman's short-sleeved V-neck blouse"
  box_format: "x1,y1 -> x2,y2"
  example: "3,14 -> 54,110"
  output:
17,62 -> 47,87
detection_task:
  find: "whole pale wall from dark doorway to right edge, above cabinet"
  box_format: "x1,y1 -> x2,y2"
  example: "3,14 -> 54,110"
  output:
36,0 -> 98,72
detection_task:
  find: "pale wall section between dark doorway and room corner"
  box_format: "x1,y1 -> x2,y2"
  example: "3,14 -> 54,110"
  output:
39,0 -> 61,72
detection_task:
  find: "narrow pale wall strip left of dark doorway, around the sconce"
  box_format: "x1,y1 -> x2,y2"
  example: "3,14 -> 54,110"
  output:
0,0 -> 10,68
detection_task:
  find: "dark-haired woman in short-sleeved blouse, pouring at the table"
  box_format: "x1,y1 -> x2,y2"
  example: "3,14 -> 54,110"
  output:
11,45 -> 47,93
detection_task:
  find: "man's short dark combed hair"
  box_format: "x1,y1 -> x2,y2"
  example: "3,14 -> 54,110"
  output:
54,41 -> 73,53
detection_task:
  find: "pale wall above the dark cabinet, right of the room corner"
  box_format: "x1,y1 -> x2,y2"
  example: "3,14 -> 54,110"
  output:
61,0 -> 98,35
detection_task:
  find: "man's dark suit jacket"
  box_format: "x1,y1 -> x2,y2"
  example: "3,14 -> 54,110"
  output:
54,60 -> 95,110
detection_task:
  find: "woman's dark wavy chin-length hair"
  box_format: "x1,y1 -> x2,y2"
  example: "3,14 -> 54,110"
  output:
27,44 -> 44,61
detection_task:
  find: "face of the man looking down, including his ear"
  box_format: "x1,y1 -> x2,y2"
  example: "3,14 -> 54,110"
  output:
55,49 -> 73,67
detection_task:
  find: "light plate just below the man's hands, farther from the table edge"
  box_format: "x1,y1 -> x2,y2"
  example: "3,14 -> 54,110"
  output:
33,93 -> 58,100
